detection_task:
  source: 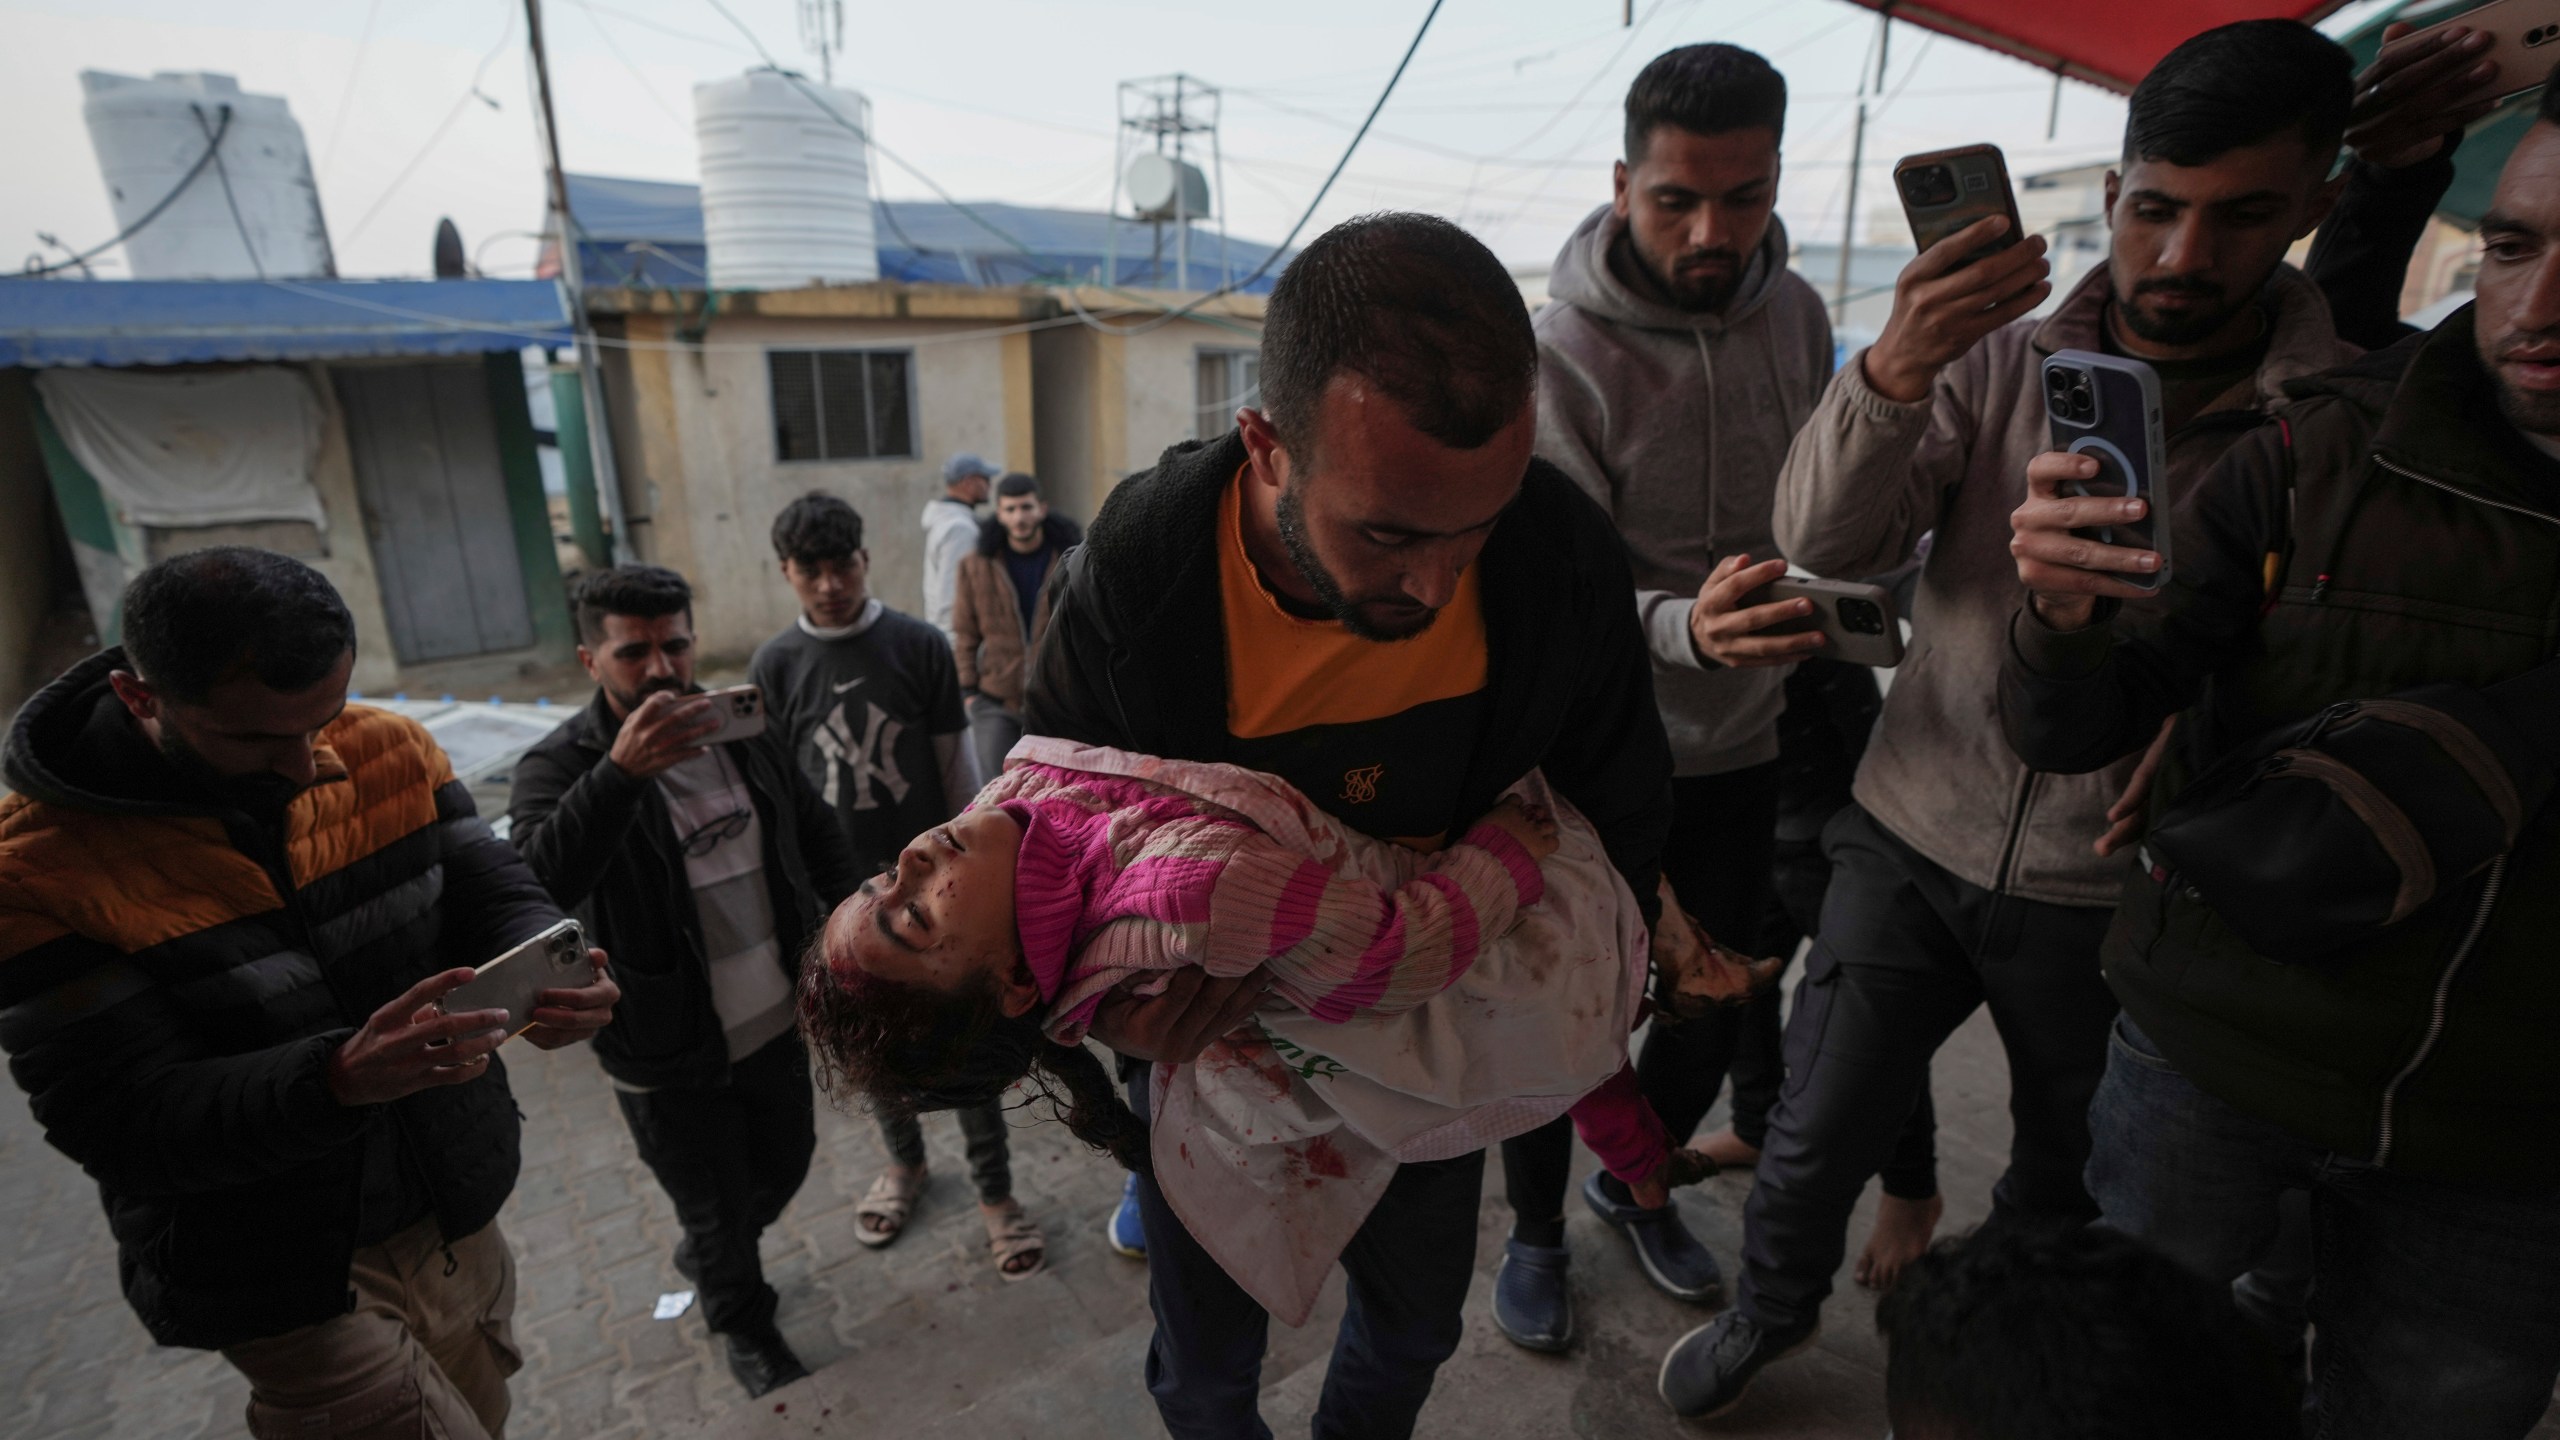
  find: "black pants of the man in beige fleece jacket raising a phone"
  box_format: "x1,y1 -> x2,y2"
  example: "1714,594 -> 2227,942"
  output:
1738,807 -> 2115,1327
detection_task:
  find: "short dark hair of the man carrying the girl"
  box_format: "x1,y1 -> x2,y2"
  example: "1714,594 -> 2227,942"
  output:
1262,210 -> 1539,464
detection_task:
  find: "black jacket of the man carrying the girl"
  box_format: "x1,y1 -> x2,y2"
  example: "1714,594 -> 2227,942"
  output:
1024,430 -> 1672,922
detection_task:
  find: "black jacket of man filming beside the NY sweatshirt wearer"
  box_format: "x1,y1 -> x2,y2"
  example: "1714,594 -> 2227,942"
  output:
507,689 -> 860,1086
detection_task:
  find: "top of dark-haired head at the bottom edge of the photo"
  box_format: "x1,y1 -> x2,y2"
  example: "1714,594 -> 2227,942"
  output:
1876,1225 -> 2299,1440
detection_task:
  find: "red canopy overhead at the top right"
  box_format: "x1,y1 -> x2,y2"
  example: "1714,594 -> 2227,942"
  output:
1851,0 -> 2345,95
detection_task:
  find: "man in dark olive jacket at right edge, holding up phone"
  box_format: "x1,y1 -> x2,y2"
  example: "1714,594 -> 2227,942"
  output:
2002,92 -> 2560,1440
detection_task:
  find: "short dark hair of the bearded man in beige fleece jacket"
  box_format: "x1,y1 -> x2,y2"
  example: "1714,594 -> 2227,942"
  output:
2125,20 -> 2355,174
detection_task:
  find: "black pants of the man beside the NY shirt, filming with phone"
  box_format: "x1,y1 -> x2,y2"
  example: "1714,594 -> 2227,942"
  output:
614,1035 -> 817,1332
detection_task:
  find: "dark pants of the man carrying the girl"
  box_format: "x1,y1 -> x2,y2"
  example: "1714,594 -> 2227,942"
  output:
1129,1068 -> 1485,1440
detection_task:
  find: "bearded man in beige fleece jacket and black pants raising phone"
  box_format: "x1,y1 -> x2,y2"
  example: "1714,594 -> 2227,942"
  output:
1661,20 -> 2473,1414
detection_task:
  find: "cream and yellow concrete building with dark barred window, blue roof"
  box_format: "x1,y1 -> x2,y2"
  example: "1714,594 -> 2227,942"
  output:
545,177 -> 1280,664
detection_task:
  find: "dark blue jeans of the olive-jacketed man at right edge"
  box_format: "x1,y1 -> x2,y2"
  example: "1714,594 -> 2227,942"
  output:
2089,1020 -> 2560,1440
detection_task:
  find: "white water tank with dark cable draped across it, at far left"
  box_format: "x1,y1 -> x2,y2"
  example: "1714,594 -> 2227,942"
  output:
79,69 -> 338,279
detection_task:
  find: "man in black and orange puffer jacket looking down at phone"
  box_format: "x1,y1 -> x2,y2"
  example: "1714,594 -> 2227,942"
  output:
0,548 -> 617,1440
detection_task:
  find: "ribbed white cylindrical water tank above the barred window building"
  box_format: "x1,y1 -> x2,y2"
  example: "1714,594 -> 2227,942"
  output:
694,69 -> 881,290
